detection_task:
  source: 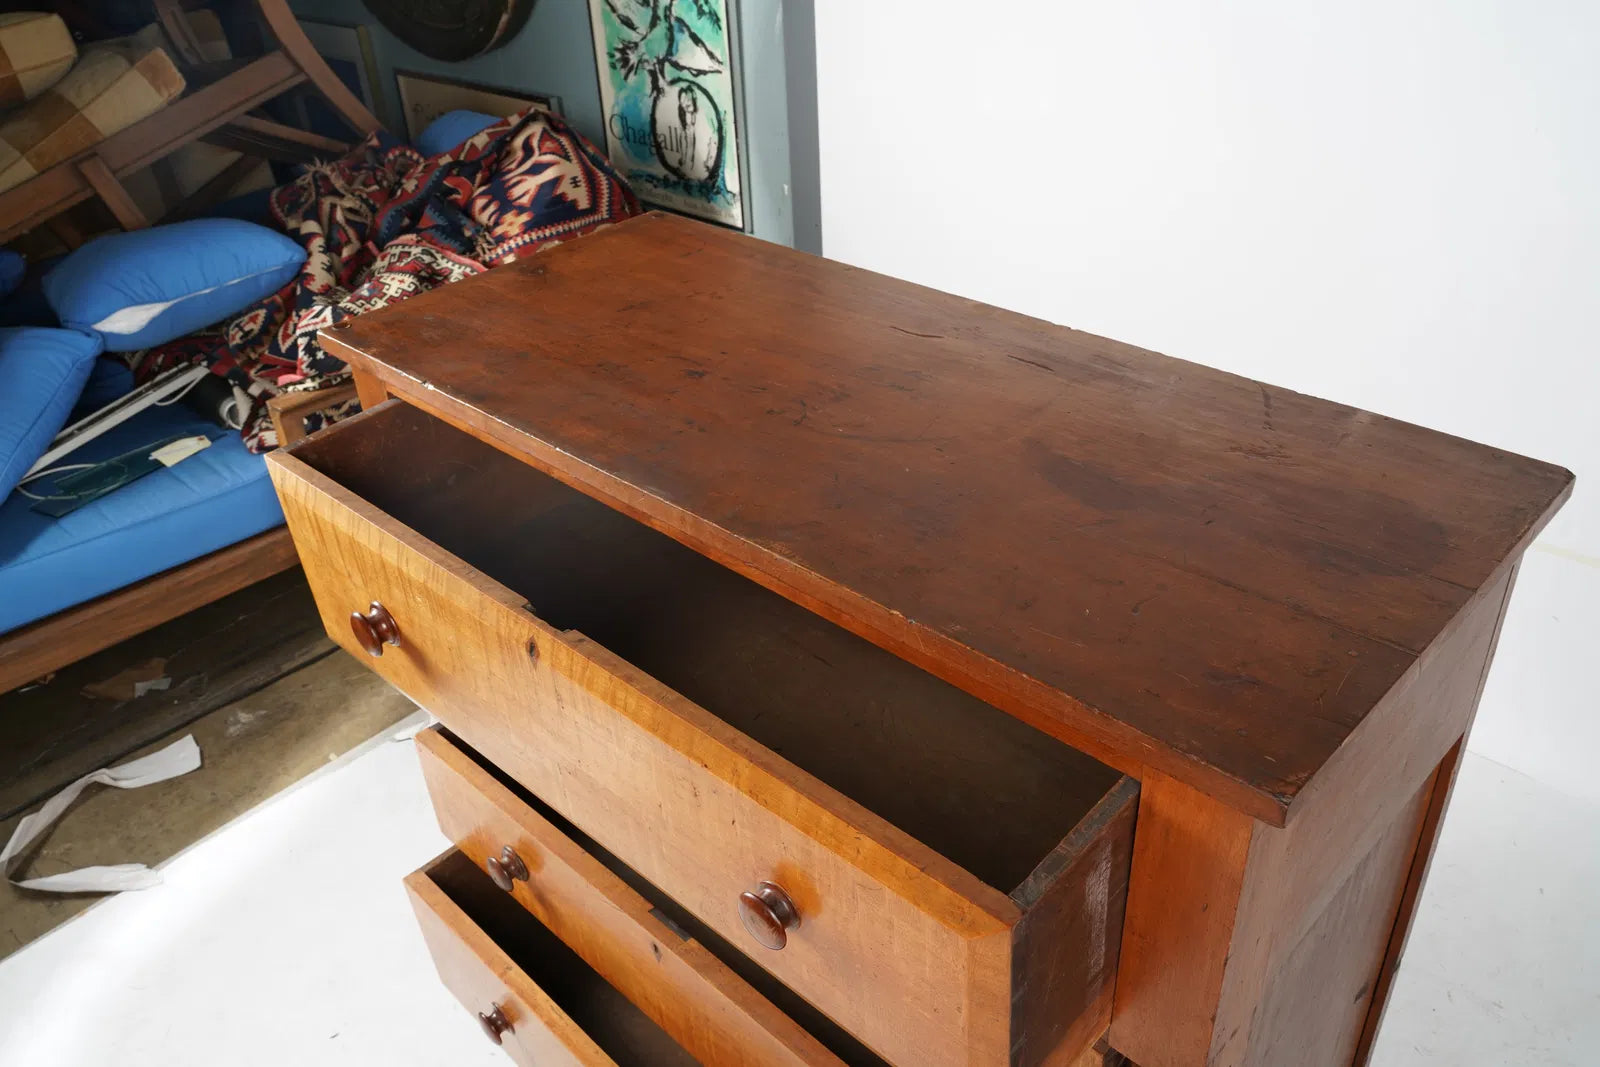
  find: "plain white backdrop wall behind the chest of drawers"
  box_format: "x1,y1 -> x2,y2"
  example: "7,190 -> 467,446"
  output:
816,0 -> 1600,798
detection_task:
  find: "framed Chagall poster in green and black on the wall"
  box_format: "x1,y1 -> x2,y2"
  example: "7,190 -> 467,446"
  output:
589,0 -> 744,230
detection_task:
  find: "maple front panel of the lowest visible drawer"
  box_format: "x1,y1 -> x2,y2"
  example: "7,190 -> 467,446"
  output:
405,869 -> 616,1067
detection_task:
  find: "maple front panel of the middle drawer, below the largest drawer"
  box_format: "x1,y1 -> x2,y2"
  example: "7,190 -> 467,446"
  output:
416,728 -> 838,1067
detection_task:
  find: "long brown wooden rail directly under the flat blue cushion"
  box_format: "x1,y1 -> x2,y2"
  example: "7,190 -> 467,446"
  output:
0,526 -> 298,693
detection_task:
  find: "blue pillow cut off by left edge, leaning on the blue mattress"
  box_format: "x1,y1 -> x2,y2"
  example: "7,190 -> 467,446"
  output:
0,326 -> 101,499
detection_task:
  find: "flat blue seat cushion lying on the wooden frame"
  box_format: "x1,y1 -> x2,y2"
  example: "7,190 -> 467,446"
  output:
0,403 -> 283,633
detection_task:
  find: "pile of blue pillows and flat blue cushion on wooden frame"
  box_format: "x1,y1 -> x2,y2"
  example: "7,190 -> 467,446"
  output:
0,219 -> 306,633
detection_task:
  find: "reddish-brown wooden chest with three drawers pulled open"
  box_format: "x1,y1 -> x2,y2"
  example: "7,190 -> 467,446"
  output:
272,216 -> 1571,1067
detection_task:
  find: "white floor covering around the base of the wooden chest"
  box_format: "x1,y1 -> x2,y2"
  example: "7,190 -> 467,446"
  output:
0,723 -> 1600,1067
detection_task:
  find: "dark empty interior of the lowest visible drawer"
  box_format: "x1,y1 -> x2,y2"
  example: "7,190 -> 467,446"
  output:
427,853 -> 696,1067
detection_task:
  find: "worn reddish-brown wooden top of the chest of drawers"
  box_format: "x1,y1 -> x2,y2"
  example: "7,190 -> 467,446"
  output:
323,216 -> 1573,824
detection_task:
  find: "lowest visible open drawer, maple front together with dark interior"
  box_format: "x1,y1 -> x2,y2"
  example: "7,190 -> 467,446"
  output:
405,853 -> 698,1067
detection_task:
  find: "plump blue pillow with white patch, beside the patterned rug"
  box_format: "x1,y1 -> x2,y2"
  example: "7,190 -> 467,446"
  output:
45,219 -> 306,352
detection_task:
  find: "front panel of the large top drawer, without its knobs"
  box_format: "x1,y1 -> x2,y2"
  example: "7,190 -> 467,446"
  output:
269,451 -> 1021,1067
